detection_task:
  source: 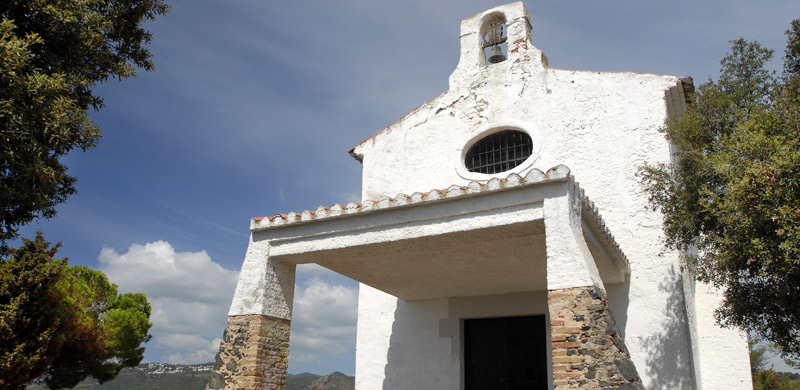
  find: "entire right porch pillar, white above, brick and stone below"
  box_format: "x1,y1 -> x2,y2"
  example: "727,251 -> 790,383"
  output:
544,175 -> 644,390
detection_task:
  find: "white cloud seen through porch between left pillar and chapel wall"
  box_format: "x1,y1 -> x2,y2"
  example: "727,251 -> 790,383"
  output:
289,274 -> 358,362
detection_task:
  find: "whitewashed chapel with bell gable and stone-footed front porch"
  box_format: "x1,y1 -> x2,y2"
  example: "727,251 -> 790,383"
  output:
209,2 -> 750,390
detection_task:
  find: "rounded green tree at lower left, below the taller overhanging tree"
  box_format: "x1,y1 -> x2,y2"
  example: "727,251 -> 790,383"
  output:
0,233 -> 152,389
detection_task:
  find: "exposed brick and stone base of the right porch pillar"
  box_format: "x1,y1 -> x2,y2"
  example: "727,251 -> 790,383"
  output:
547,287 -> 644,390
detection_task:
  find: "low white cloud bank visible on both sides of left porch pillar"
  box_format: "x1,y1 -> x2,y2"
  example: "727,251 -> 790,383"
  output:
94,241 -> 358,371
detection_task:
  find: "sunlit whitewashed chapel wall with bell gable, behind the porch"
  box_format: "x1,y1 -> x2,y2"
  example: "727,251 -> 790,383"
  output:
351,3 -> 749,390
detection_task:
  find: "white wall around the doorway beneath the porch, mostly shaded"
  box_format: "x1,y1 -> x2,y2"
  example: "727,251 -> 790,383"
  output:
356,285 -> 550,389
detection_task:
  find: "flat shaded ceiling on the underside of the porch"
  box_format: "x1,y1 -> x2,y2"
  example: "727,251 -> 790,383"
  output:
280,220 -> 547,300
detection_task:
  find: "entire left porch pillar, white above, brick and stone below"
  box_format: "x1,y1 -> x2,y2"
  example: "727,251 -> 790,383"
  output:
206,232 -> 295,390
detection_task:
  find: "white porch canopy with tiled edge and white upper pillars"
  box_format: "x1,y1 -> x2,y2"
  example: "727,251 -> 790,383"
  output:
229,165 -> 630,319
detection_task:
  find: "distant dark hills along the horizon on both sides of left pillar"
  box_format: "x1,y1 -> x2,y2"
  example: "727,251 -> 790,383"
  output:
28,363 -> 355,390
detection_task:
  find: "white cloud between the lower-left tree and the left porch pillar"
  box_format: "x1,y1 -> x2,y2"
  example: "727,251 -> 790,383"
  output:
99,241 -> 239,363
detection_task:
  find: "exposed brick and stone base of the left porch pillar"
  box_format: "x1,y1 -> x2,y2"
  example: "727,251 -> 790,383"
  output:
206,315 -> 291,390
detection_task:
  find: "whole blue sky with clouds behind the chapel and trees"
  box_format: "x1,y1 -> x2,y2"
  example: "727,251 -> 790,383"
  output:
12,0 -> 800,375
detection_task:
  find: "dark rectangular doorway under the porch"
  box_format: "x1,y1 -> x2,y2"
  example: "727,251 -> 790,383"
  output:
464,315 -> 548,390
